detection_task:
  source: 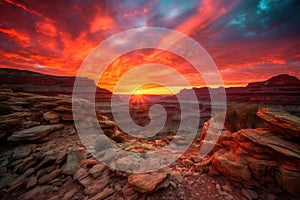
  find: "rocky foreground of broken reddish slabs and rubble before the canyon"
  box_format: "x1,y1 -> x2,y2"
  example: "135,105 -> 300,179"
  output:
0,90 -> 300,200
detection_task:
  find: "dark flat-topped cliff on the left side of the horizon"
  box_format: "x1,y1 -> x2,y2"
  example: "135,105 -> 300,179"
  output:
0,69 -> 111,101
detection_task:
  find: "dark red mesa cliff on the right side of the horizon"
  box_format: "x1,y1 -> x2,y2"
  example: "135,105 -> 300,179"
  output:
179,74 -> 300,105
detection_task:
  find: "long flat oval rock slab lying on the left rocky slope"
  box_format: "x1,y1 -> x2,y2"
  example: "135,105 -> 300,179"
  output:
7,124 -> 64,142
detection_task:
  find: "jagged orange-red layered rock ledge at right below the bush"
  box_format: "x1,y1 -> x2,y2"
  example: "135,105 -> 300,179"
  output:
201,108 -> 300,196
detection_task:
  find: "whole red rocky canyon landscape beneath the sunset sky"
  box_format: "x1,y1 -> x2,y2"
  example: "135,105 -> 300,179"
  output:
0,69 -> 300,200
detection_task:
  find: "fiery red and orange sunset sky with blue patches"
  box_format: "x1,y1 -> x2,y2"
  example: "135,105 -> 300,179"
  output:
0,0 -> 300,93
